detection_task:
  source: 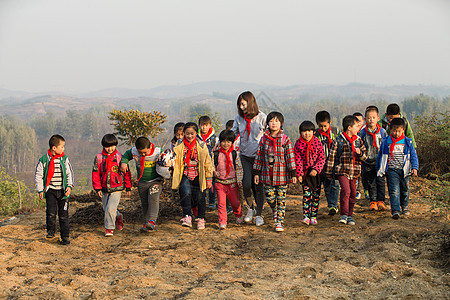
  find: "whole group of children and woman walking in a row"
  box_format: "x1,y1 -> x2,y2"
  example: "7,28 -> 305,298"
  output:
35,92 -> 418,245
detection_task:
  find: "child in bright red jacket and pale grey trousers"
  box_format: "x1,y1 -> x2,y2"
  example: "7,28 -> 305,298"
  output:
92,134 -> 131,236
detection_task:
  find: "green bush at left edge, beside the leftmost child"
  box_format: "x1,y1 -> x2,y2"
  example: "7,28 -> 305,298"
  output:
0,167 -> 45,215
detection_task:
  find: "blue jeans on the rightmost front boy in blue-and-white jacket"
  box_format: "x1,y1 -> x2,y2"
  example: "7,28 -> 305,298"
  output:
386,168 -> 409,214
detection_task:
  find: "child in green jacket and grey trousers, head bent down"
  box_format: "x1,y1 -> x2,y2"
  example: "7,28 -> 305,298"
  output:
121,136 -> 163,233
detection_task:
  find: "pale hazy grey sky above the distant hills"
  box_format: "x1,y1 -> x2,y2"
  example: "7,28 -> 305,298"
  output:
0,0 -> 450,92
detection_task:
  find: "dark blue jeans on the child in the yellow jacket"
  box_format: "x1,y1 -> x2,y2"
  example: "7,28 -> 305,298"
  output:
179,175 -> 206,219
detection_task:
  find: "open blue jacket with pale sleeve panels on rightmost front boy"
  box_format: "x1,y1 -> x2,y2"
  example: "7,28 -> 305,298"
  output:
376,135 -> 419,177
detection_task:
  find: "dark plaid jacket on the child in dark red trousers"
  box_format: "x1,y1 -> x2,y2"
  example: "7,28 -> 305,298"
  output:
325,133 -> 367,180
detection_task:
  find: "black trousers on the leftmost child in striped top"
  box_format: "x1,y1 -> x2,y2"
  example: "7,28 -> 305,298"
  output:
45,189 -> 69,238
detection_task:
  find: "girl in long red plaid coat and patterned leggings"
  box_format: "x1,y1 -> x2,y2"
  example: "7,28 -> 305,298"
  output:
253,112 -> 297,232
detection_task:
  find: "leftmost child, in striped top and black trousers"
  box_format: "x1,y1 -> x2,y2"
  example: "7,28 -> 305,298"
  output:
35,134 -> 73,245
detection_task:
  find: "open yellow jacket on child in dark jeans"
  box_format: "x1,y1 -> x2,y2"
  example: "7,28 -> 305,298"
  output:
172,139 -> 213,192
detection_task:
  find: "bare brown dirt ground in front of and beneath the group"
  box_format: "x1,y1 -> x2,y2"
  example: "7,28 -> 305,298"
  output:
0,179 -> 450,299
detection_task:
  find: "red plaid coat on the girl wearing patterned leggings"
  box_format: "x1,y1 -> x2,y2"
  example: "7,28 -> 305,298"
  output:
253,131 -> 296,185
